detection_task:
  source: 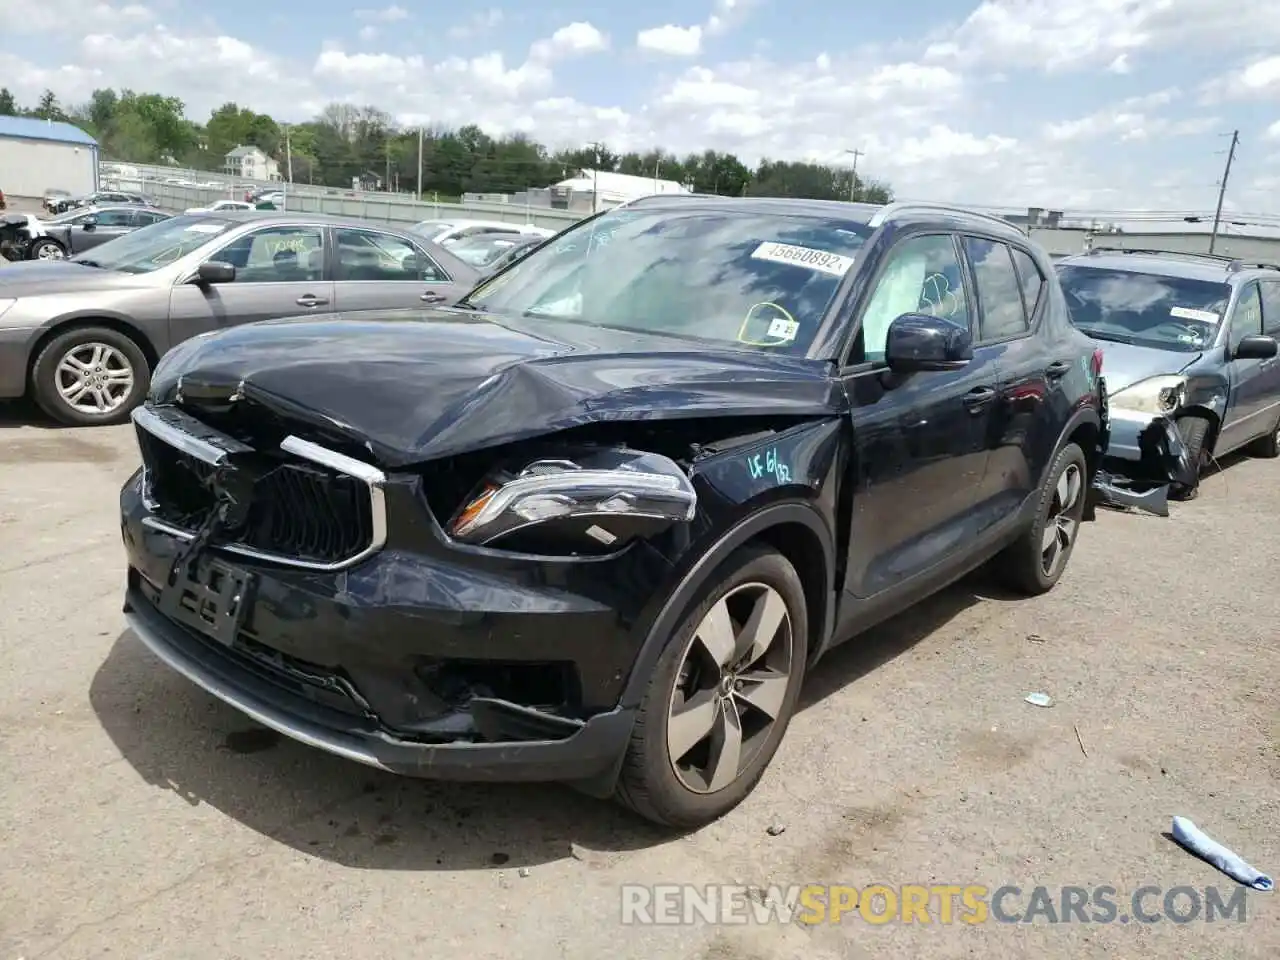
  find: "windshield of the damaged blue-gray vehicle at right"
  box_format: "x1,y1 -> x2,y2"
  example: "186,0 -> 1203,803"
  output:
1057,264 -> 1231,353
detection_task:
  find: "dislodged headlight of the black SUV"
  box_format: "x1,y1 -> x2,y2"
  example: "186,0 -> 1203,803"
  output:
449,449 -> 698,553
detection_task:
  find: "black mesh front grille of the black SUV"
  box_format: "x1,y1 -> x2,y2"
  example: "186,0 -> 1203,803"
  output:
138,425 -> 375,566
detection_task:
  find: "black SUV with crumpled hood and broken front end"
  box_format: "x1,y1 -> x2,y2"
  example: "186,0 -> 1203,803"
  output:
120,196 -> 1106,826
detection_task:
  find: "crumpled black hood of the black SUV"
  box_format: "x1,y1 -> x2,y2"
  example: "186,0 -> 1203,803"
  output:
152,310 -> 844,467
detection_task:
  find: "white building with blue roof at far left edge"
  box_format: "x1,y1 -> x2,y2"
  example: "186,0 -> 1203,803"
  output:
0,116 -> 99,200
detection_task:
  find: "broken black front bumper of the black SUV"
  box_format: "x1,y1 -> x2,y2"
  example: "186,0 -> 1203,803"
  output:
120,475 -> 652,796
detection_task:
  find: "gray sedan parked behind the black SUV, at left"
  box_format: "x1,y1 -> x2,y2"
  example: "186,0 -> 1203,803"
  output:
0,211 -> 479,426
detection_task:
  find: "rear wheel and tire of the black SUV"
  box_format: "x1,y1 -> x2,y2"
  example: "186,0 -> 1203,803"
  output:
993,443 -> 1089,596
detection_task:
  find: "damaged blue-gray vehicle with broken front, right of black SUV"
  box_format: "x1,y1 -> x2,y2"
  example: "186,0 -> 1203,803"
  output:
1055,247 -> 1280,499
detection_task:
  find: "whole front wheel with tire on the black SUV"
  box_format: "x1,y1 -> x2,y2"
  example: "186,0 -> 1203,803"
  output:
614,547 -> 809,828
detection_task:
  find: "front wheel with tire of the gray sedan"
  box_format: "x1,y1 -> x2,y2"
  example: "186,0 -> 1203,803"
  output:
31,326 -> 151,426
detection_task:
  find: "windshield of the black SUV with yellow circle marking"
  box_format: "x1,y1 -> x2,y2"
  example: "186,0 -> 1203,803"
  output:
465,207 -> 873,355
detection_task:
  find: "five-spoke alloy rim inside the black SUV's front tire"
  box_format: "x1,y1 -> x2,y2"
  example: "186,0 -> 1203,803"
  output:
667,582 -> 795,794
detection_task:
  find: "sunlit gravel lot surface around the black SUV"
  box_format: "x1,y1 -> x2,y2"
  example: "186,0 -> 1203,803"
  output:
0,404 -> 1280,960
